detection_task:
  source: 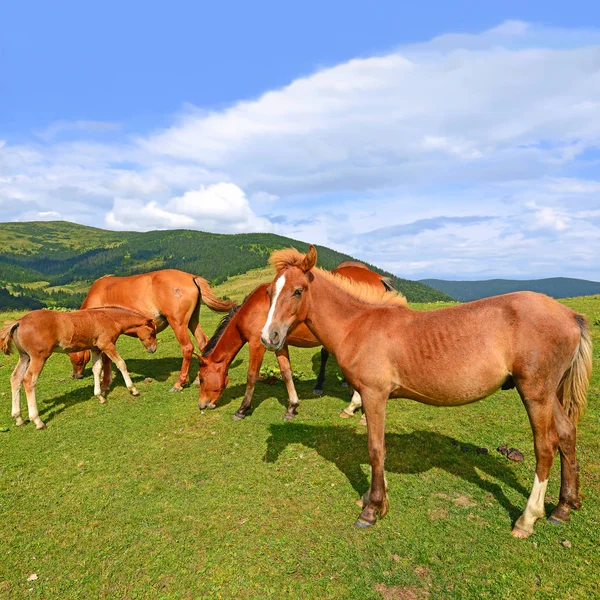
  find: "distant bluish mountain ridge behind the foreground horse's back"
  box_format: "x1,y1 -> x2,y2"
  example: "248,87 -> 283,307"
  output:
420,277 -> 600,302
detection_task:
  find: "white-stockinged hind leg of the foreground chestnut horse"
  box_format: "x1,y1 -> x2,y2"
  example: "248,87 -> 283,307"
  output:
511,387 -> 559,538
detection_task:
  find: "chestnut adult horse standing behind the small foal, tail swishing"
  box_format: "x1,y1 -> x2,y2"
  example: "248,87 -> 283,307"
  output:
70,269 -> 235,392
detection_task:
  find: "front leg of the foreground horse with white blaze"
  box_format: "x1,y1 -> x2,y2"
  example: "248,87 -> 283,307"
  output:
355,388 -> 389,527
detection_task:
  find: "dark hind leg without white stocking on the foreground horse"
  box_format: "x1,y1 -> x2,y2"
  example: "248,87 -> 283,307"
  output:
548,400 -> 581,524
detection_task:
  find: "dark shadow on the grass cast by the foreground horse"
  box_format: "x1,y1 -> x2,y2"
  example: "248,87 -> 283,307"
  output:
264,423 -> 529,522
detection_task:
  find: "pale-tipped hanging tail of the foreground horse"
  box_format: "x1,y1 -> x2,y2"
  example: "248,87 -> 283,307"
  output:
557,314 -> 592,425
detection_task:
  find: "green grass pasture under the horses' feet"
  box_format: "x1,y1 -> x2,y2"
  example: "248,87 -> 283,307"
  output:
0,296 -> 600,599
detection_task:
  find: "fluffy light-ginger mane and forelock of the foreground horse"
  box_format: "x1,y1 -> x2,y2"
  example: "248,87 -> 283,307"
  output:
269,248 -> 406,306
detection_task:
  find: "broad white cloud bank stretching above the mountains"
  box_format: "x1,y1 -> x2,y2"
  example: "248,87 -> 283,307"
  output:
0,21 -> 600,279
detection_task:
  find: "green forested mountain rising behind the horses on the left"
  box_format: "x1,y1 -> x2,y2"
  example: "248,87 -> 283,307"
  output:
0,221 -> 449,307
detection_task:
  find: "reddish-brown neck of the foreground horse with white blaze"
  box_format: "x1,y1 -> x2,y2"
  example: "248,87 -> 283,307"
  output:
306,274 -> 376,351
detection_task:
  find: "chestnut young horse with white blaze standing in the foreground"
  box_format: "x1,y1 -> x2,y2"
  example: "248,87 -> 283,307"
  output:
261,246 -> 592,538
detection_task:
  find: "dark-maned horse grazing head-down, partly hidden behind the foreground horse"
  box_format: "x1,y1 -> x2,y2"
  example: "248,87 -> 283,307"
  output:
198,262 -> 393,421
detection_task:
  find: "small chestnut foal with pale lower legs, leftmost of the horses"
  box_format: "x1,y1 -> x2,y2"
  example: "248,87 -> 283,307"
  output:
0,307 -> 156,429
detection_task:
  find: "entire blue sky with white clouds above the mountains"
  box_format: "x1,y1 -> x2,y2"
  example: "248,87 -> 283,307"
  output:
0,1 -> 600,279
